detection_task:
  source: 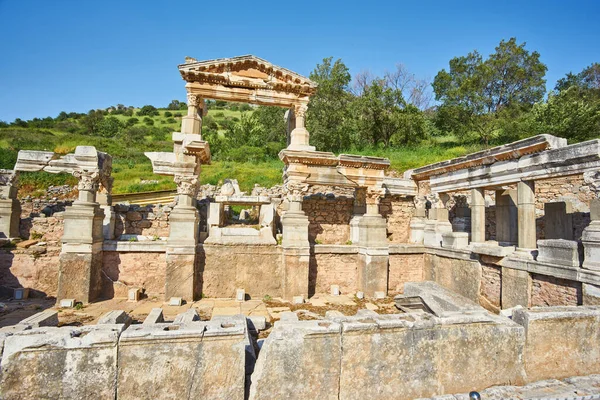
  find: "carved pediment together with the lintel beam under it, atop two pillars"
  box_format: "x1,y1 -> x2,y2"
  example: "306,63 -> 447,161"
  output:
179,55 -> 317,108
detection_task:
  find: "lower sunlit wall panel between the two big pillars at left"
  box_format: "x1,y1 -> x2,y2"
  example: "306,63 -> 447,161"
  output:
102,251 -> 166,299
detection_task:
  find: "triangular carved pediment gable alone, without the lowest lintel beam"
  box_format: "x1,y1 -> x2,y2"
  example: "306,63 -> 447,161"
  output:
179,55 -> 317,95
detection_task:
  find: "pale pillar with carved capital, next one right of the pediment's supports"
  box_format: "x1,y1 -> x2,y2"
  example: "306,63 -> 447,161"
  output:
358,189 -> 390,296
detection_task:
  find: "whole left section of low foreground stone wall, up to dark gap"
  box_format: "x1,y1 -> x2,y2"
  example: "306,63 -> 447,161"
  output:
0,309 -> 248,400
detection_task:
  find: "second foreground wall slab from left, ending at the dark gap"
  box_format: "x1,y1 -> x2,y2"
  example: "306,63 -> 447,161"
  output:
117,316 -> 247,400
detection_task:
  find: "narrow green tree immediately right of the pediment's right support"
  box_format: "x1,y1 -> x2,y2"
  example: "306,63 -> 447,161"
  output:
306,57 -> 355,151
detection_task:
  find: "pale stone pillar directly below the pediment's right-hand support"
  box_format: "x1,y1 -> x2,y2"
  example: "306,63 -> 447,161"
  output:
281,193 -> 310,299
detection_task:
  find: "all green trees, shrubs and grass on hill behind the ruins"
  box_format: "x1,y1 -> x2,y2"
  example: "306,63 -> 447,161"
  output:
0,38 -> 600,194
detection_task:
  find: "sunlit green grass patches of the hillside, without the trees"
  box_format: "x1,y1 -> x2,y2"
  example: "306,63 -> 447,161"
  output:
0,109 -> 479,195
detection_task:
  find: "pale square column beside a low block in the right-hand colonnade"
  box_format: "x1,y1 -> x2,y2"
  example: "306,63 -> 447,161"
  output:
515,181 -> 536,258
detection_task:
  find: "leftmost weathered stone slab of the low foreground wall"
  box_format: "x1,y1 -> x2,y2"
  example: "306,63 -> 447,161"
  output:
0,325 -> 124,399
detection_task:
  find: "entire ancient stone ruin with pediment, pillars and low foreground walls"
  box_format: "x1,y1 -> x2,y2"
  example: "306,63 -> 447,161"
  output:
0,56 -> 600,399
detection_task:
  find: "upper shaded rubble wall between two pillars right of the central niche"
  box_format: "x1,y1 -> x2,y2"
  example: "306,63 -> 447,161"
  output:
302,194 -> 354,244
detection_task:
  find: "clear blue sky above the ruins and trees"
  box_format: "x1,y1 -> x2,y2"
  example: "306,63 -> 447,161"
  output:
0,0 -> 600,121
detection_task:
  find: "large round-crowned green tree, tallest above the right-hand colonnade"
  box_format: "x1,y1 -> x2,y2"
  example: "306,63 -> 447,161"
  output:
433,38 -> 547,145
